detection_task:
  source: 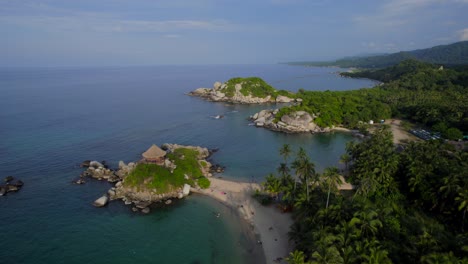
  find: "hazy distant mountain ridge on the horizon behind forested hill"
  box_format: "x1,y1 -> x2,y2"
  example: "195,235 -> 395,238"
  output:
288,41 -> 468,69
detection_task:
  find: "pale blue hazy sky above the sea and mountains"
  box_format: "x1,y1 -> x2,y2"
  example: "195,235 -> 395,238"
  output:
0,0 -> 468,67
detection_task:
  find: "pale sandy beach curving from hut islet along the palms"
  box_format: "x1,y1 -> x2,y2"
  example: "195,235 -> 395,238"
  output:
191,178 -> 293,263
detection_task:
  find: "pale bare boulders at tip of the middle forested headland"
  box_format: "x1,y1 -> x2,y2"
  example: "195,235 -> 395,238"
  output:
250,109 -> 330,133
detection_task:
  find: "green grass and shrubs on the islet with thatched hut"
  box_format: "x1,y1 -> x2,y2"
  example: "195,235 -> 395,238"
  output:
124,148 -> 210,193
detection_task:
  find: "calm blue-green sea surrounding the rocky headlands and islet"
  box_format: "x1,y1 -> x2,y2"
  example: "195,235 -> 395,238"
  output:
0,65 -> 374,264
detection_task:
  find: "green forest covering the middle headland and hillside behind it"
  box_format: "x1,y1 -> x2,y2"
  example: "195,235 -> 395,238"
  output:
277,60 -> 468,134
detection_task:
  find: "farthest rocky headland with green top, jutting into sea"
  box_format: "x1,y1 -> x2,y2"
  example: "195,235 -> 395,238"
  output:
189,77 -> 295,104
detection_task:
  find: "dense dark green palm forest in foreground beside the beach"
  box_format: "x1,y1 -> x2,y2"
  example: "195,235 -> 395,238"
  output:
264,130 -> 468,263
